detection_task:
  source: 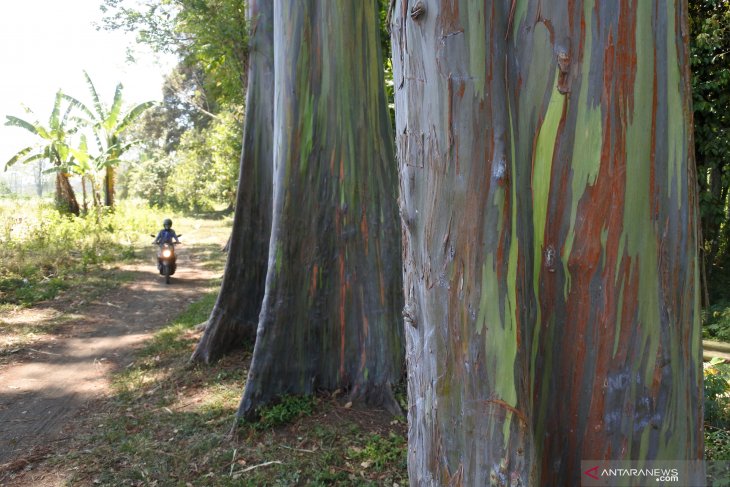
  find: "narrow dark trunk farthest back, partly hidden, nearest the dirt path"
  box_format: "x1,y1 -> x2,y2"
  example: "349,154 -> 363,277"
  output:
191,0 -> 274,363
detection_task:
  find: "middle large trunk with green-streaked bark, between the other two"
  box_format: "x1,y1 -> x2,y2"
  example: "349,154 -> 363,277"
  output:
239,0 -> 403,416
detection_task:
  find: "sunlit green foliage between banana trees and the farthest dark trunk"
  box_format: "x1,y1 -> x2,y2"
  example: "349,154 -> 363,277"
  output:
102,0 -> 249,212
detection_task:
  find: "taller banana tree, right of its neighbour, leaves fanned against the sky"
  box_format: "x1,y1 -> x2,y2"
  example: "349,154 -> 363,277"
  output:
65,71 -> 155,207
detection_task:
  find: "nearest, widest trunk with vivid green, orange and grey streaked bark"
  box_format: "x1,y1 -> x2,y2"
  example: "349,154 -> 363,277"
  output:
392,0 -> 702,485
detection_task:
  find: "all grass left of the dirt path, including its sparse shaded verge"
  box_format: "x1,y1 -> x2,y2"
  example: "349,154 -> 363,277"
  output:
0,199 -> 231,358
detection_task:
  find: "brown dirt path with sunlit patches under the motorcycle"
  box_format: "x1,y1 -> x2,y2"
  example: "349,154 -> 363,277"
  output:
0,252 -> 220,465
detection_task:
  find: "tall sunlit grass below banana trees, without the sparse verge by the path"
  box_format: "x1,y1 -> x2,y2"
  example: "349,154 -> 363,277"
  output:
0,196 -> 231,306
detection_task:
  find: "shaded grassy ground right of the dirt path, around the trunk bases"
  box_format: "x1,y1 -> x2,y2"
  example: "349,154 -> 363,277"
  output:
0,293 -> 407,486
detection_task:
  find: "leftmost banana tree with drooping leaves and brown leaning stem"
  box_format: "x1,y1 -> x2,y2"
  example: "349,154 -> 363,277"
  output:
5,90 -> 79,215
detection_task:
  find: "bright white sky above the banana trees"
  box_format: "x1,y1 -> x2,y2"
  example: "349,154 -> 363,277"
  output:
0,0 -> 173,186
